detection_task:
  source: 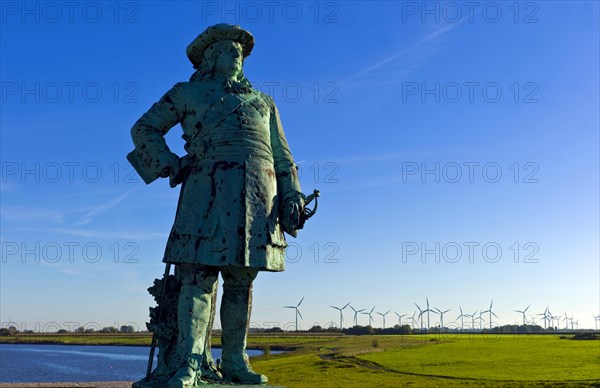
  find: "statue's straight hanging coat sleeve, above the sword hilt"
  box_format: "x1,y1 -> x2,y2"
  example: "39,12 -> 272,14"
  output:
267,96 -> 304,208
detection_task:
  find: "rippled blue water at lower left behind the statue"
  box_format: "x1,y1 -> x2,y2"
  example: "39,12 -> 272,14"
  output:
0,344 -> 268,383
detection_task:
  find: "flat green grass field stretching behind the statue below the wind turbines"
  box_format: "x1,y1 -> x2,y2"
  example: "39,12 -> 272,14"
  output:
0,334 -> 600,387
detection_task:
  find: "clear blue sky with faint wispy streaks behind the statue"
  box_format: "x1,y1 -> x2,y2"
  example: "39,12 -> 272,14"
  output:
0,1 -> 600,330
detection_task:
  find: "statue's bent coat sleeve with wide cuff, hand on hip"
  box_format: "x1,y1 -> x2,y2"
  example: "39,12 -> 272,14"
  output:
127,83 -> 183,183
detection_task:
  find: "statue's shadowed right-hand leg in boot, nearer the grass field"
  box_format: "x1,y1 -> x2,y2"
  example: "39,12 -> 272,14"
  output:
221,267 -> 267,384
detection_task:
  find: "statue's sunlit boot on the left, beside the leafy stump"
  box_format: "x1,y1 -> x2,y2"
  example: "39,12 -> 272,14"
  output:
168,284 -> 212,388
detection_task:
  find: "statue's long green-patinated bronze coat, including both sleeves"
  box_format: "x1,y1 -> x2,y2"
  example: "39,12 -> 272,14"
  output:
131,81 -> 302,271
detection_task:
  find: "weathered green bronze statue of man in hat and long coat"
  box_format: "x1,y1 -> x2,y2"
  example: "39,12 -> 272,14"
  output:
128,24 -> 305,387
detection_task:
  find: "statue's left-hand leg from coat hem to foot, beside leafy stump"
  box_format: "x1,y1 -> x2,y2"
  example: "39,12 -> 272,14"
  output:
168,264 -> 218,388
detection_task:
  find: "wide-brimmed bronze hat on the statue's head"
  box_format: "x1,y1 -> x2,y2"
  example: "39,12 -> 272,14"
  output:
185,23 -> 254,67
